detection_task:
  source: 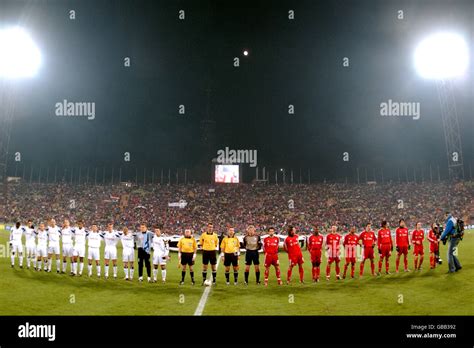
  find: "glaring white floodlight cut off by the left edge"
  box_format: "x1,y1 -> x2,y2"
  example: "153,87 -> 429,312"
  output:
0,27 -> 41,79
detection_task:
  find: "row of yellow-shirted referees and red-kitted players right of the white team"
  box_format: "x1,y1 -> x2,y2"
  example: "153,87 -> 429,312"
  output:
178,219 -> 440,285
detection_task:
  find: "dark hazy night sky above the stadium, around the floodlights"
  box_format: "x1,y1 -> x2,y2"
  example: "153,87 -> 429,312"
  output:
0,0 -> 474,182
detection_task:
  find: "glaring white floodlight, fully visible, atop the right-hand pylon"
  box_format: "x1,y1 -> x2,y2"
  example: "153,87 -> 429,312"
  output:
415,33 -> 469,80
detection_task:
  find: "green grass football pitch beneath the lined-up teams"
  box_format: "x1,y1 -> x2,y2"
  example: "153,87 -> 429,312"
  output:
0,230 -> 474,315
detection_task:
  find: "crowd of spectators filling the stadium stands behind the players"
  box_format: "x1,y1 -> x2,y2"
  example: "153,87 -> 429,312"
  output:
3,181 -> 474,234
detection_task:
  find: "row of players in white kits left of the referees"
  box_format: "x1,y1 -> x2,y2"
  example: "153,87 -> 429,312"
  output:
10,219 -> 169,282
